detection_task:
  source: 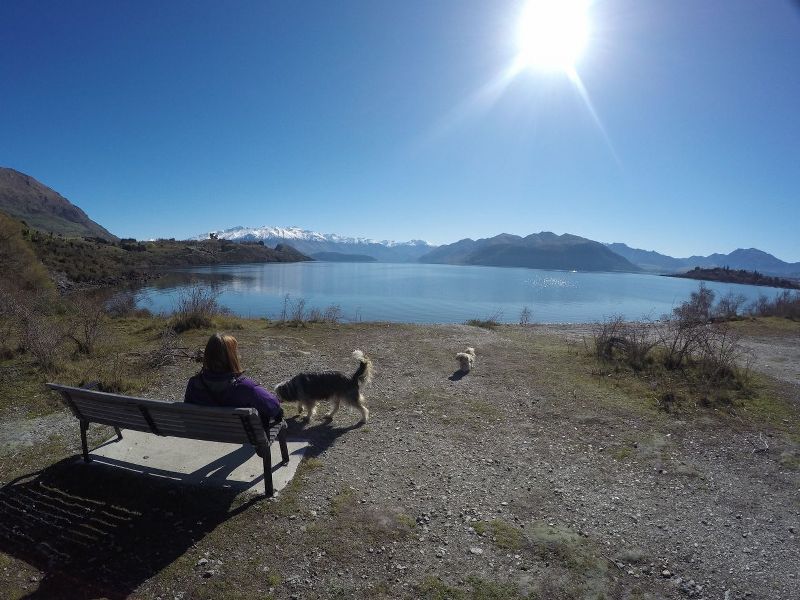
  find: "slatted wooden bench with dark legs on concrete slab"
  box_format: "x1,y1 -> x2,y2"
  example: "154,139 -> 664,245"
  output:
47,383 -> 289,496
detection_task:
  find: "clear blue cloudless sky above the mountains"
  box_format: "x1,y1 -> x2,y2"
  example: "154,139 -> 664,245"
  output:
0,0 -> 800,261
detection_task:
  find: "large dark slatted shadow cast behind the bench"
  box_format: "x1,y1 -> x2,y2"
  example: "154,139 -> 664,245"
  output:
0,457 -> 260,600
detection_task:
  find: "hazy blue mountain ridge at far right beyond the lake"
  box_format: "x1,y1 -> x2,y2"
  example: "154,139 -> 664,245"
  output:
606,242 -> 800,277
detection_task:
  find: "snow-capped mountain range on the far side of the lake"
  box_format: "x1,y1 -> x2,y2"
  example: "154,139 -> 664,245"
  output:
197,226 -> 435,262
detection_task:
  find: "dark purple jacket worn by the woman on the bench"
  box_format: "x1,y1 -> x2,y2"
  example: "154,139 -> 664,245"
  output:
183,371 -> 283,429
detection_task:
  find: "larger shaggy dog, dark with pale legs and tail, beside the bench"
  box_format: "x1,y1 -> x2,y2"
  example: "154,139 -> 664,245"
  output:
275,350 -> 372,423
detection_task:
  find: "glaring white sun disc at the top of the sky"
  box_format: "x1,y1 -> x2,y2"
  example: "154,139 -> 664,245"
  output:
517,0 -> 589,73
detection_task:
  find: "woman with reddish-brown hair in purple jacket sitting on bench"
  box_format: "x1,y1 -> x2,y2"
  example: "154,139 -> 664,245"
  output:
183,333 -> 283,431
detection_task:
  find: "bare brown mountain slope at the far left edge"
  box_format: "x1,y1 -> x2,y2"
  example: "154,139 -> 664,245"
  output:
0,167 -> 118,241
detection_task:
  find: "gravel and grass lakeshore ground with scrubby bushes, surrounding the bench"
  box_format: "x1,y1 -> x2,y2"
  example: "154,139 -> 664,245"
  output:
0,274 -> 800,600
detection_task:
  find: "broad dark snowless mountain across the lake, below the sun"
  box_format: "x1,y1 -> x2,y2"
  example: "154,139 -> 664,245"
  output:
419,231 -> 640,272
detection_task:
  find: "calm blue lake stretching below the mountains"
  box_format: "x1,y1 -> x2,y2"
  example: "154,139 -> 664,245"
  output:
140,262 -> 779,323
